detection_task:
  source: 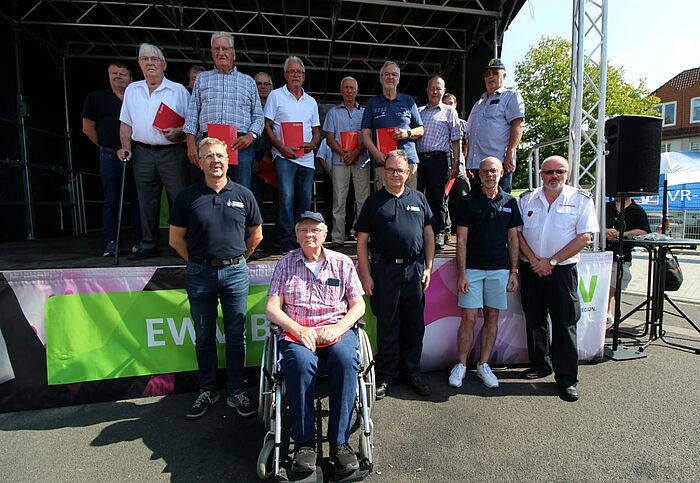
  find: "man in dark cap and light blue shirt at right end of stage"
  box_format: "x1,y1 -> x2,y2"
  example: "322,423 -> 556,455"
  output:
466,59 -> 525,193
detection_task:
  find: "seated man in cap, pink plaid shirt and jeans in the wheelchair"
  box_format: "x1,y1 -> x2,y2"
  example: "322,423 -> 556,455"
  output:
266,211 -> 365,475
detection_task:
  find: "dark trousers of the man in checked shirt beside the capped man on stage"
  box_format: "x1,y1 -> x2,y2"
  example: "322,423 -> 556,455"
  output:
418,152 -> 451,235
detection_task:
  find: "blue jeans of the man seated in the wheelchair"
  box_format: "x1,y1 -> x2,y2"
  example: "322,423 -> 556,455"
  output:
282,329 -> 360,445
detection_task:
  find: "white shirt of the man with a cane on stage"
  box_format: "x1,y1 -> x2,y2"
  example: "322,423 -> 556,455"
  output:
119,77 -> 190,145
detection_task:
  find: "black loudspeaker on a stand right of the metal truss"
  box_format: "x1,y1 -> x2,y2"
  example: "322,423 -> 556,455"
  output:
605,116 -> 661,196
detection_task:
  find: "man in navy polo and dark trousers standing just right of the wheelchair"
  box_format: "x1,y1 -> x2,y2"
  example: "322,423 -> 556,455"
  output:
355,149 -> 435,399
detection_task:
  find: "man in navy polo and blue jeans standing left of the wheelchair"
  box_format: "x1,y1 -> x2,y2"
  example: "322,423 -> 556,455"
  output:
170,138 -> 262,419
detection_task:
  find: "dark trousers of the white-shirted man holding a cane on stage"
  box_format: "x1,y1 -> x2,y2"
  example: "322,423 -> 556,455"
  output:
131,143 -> 190,250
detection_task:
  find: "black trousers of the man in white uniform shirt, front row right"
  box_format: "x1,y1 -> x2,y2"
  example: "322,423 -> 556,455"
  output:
520,262 -> 581,387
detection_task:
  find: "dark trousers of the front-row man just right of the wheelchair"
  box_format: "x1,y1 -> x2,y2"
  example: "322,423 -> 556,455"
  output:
370,261 -> 425,382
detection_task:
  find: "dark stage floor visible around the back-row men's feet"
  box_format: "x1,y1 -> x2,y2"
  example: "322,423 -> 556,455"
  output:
0,229 -> 456,271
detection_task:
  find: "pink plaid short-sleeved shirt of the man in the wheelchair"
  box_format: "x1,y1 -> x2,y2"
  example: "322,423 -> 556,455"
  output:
267,248 -> 364,327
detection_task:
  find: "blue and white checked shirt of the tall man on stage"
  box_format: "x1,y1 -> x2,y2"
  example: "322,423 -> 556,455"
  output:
183,67 -> 264,136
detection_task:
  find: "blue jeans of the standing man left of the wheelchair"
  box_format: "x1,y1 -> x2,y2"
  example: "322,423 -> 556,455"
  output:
187,257 -> 249,396
